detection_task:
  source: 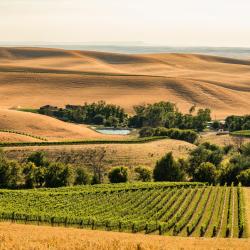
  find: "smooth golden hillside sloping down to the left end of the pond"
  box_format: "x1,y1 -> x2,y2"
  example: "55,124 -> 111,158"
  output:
0,109 -> 127,142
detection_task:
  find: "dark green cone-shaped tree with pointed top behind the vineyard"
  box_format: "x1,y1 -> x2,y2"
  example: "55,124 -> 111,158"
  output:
153,152 -> 185,181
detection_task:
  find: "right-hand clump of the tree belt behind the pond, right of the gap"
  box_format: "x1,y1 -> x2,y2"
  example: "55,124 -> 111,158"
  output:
129,102 -> 211,131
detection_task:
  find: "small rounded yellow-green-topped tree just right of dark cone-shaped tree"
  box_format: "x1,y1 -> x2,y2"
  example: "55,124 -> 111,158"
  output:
193,162 -> 217,184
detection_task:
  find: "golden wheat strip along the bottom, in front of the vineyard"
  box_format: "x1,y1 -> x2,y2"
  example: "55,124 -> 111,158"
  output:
0,223 -> 250,250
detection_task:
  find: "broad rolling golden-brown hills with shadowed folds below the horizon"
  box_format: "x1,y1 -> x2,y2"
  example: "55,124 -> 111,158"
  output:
0,48 -> 250,119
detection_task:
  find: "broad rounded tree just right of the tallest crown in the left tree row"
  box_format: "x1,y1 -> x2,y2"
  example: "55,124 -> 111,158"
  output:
45,162 -> 74,187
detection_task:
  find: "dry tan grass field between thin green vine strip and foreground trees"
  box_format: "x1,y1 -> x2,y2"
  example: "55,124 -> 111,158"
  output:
5,139 -> 196,168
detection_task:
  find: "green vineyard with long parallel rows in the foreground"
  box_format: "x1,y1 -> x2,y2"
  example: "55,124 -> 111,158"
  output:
0,182 -> 246,238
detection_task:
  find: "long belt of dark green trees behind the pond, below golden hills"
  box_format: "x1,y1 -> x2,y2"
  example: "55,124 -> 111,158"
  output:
39,101 -> 211,131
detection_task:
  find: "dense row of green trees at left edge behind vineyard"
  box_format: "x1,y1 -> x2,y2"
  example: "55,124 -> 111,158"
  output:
0,152 -> 89,189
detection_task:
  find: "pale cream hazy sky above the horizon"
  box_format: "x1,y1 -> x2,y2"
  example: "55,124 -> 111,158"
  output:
0,0 -> 250,47
